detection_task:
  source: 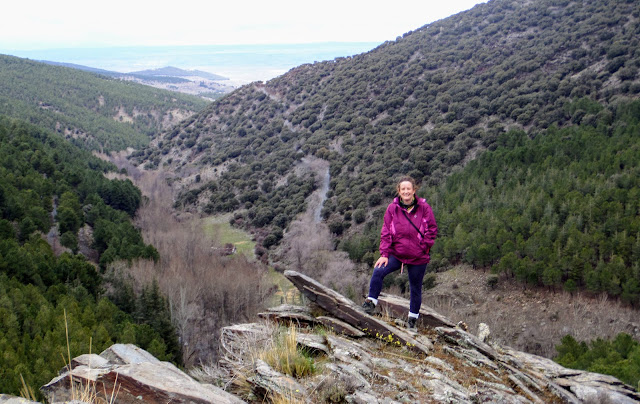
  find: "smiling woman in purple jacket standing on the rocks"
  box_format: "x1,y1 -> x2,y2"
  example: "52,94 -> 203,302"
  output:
362,176 -> 438,329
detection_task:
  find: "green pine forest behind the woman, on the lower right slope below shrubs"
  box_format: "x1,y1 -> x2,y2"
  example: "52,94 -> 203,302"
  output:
342,101 -> 640,307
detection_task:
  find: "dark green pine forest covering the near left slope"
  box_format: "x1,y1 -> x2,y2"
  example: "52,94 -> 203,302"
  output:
0,116 -> 181,400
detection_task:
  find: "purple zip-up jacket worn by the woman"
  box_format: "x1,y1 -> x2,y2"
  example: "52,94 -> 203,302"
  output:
380,198 -> 438,265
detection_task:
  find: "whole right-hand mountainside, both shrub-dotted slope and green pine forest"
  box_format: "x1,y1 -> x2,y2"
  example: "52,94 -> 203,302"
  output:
127,0 -> 640,306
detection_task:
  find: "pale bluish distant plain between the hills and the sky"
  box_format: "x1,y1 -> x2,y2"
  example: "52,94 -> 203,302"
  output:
0,42 -> 379,85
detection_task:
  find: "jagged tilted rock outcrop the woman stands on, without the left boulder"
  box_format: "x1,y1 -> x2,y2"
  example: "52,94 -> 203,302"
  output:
215,271 -> 640,403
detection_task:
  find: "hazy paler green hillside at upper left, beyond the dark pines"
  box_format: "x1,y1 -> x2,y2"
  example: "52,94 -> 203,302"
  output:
0,55 -> 206,152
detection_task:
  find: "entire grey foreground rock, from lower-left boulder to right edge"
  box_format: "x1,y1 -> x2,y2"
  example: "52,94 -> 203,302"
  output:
42,271 -> 640,404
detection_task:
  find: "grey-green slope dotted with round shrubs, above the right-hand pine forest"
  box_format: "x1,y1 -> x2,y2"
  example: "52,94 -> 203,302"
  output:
139,0 -> 640,219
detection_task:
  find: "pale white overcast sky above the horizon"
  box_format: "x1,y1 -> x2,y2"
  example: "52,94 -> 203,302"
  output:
0,0 -> 486,50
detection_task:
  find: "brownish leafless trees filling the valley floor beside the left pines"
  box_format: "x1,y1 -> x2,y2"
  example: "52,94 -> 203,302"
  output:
105,172 -> 271,367
